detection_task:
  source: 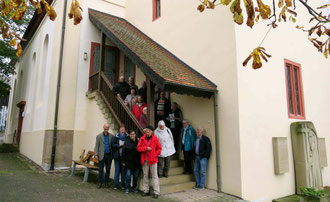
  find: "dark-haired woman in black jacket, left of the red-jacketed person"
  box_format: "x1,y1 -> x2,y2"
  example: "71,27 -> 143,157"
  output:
122,131 -> 141,194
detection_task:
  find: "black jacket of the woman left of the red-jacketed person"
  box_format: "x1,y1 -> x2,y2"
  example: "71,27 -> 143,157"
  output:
121,138 -> 141,170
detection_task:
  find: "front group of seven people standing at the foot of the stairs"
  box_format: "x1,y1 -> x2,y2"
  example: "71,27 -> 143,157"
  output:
94,120 -> 211,198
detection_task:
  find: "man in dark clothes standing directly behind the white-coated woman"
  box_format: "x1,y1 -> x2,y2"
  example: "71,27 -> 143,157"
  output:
155,92 -> 171,123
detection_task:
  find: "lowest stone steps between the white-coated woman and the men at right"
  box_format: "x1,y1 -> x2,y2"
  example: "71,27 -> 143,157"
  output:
159,154 -> 196,194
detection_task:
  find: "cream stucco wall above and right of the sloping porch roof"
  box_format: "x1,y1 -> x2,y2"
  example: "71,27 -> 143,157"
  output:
126,0 -> 241,196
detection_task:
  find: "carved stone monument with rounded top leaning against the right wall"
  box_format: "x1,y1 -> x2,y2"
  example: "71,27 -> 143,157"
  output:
291,122 -> 322,194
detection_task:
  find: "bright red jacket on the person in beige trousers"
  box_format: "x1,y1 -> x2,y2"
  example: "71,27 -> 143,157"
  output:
137,134 -> 162,165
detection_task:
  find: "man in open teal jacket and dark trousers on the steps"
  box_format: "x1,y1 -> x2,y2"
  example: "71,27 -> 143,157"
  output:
180,120 -> 196,175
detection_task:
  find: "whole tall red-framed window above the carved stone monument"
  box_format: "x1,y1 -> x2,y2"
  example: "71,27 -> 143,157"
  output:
284,60 -> 305,119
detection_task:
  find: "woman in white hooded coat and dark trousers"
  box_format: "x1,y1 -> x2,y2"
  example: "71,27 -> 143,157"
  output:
154,120 -> 175,178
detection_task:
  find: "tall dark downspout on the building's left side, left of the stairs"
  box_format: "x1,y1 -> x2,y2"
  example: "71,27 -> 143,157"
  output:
49,0 -> 67,170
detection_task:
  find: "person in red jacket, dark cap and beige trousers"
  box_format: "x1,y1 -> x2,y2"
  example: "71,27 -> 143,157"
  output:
137,126 -> 162,198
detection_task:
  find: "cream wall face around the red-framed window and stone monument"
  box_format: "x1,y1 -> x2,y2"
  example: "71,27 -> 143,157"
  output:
235,2 -> 330,201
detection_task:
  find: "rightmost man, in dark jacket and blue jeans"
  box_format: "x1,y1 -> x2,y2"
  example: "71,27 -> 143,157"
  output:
194,126 -> 212,189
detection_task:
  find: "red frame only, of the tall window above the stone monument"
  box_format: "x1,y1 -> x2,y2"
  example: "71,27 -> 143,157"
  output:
284,59 -> 306,120
